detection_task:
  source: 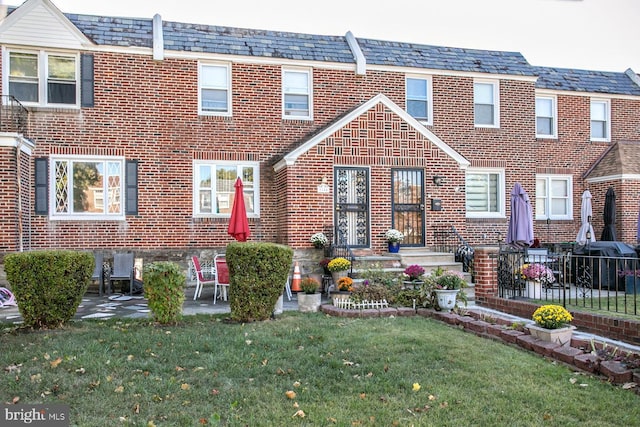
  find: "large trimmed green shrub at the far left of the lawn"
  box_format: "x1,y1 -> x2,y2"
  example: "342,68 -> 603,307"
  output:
4,250 -> 95,328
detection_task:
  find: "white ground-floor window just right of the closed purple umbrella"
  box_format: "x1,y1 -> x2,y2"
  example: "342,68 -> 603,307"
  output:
536,175 -> 573,219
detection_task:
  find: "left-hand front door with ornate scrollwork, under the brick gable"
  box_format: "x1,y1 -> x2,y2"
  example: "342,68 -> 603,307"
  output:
333,167 -> 370,247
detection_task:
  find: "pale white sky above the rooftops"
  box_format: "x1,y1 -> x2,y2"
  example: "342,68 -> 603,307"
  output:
5,0 -> 640,73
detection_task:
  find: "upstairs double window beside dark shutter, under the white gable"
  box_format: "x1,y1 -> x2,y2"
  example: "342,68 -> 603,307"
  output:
3,51 -> 80,106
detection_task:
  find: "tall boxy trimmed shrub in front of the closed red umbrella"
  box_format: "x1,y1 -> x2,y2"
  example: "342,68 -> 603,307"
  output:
226,242 -> 293,322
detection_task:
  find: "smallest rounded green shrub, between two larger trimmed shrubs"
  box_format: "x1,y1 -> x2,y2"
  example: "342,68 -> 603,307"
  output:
144,261 -> 187,325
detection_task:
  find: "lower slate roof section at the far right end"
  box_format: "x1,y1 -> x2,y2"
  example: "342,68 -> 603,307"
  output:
535,67 -> 640,96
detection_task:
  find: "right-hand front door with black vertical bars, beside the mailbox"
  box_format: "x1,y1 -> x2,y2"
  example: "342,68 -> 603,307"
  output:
391,169 -> 424,246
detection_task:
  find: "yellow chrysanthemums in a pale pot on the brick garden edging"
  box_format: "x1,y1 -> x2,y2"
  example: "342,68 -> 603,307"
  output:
527,304 -> 575,345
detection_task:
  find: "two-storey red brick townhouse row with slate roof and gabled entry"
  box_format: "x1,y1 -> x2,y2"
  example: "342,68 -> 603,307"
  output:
0,0 -> 640,268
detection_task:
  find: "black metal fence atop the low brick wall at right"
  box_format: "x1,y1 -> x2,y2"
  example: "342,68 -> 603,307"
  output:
498,246 -> 640,316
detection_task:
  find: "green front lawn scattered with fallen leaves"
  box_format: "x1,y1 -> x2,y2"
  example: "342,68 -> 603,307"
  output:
0,312 -> 640,427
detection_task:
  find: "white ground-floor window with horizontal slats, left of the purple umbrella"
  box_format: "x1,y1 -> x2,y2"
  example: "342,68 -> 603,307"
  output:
465,168 -> 505,218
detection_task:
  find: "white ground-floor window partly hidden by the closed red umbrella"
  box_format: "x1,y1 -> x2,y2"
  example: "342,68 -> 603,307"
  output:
193,160 -> 260,218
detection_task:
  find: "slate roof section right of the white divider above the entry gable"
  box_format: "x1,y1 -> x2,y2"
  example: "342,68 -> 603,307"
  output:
358,38 -> 535,76
